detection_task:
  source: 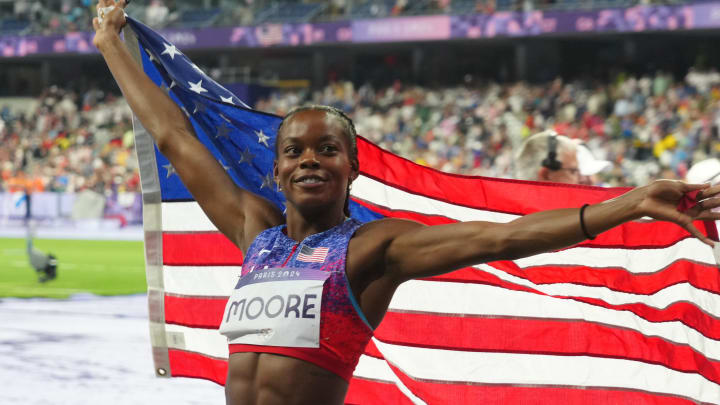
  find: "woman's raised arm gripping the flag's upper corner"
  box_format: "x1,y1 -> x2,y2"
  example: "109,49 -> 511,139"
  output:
93,0 -> 283,252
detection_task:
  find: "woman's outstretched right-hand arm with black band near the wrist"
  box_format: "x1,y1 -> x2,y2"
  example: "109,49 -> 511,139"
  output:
384,180 -> 720,283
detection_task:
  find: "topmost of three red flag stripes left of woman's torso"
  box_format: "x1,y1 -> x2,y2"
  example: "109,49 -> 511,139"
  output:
163,232 -> 243,266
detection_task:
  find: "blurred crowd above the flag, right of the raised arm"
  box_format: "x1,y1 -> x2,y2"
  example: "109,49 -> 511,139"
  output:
257,69 -> 720,186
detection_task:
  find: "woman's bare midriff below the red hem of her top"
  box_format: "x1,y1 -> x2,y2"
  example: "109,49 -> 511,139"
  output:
225,353 -> 348,405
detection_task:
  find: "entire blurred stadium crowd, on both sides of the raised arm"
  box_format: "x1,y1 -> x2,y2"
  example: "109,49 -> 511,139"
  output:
0,69 -> 720,194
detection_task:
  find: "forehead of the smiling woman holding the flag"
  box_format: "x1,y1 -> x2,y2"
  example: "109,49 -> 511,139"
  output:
278,110 -> 346,142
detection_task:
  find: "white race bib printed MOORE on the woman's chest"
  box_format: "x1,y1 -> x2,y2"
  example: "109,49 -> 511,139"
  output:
220,268 -> 330,347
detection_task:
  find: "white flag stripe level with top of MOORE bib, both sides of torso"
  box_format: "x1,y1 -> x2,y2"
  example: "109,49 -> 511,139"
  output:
164,266 -> 720,359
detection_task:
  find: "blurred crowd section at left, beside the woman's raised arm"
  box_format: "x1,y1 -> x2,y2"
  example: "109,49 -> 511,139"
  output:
0,86 -> 140,195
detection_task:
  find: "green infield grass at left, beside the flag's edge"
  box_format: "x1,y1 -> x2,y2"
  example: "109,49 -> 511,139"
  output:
0,238 -> 146,298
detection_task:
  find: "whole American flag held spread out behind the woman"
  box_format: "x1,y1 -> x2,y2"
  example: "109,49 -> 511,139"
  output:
125,19 -> 720,405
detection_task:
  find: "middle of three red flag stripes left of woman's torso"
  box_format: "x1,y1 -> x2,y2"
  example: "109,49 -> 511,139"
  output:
165,294 -> 228,329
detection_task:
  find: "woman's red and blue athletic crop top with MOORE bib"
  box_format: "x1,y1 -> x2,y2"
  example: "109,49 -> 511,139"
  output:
220,219 -> 373,381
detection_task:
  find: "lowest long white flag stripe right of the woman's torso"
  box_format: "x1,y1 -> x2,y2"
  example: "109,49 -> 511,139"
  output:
375,340 -> 720,403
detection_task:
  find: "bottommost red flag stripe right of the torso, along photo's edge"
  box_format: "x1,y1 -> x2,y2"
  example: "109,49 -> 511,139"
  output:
390,364 -> 697,405
